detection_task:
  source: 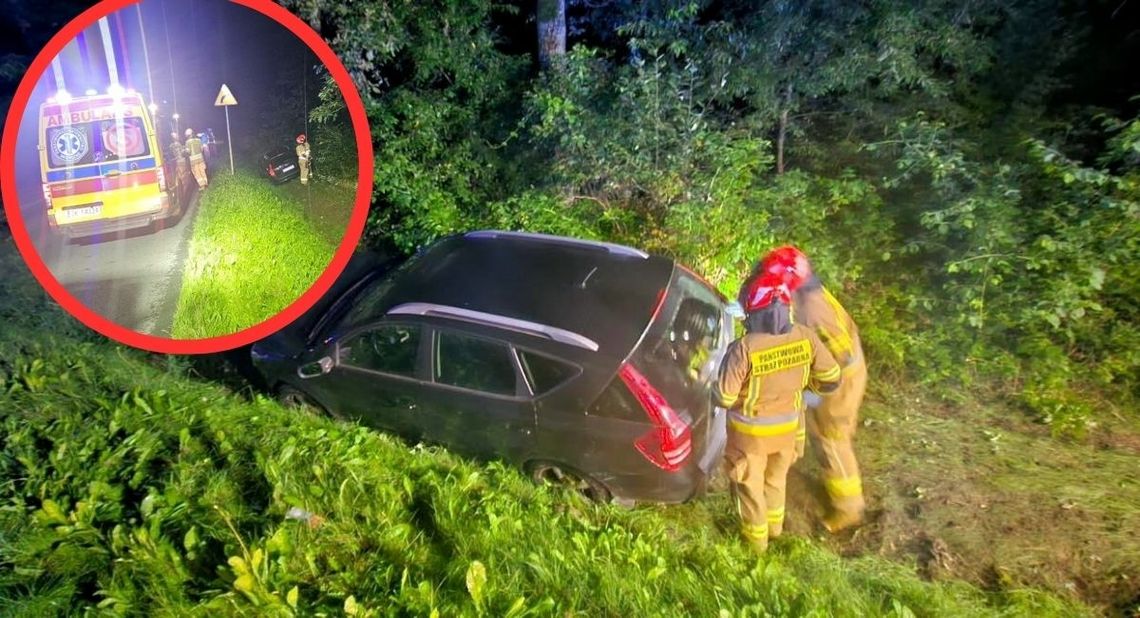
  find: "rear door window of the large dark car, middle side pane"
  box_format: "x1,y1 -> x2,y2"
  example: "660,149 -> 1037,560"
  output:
433,331 -> 516,396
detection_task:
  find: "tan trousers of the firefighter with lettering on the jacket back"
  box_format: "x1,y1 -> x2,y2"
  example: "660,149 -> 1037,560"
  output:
724,430 -> 796,552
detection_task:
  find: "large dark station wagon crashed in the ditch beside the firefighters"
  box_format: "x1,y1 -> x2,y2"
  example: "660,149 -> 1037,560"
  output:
251,231 -> 733,503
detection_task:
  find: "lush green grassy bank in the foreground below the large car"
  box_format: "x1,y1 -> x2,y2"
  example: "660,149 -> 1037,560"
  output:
0,234 -> 1086,616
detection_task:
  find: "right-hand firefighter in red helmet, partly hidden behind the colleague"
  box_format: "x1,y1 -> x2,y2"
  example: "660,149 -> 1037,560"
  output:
754,246 -> 866,532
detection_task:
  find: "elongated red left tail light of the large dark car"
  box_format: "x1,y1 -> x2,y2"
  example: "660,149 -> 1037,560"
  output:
618,363 -> 693,472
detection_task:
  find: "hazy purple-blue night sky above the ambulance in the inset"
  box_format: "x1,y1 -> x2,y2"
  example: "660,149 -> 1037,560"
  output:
17,0 -> 320,214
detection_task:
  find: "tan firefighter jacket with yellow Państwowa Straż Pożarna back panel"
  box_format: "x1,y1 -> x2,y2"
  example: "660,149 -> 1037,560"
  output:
715,324 -> 840,436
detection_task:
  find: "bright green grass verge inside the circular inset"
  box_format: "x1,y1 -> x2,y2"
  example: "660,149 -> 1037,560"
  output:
172,172 -> 335,339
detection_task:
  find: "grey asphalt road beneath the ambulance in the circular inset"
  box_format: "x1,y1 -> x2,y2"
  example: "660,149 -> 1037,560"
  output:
19,178 -> 198,338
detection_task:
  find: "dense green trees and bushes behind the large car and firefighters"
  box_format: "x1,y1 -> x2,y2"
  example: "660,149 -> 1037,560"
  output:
278,0 -> 1140,434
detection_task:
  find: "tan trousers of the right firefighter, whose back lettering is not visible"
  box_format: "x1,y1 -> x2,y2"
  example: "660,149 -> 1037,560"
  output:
807,358 -> 866,519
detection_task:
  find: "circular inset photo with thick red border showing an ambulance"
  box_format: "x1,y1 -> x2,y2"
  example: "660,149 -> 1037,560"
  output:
0,0 -> 372,353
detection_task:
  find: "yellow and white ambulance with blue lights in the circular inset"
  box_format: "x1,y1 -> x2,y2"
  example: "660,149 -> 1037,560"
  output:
39,88 -> 176,238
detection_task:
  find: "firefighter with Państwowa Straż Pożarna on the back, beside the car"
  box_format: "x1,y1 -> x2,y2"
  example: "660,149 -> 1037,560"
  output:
715,278 -> 841,552
